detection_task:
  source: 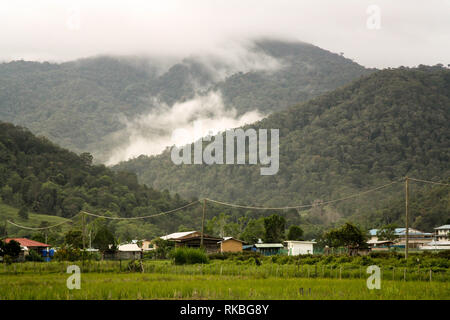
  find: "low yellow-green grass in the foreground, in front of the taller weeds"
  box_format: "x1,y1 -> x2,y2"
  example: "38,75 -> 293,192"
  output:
0,273 -> 450,300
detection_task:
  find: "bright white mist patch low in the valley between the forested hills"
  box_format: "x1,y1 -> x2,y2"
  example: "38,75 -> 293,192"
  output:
106,92 -> 263,165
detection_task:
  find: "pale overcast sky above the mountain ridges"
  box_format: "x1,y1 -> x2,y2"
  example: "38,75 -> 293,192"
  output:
0,0 -> 450,68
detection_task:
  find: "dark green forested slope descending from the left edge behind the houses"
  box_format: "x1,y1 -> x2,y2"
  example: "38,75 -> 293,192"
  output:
0,122 -> 204,239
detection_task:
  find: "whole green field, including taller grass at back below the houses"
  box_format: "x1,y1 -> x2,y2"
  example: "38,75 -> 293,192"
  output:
0,256 -> 450,300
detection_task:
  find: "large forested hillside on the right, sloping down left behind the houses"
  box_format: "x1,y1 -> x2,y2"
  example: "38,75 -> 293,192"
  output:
115,66 -> 450,229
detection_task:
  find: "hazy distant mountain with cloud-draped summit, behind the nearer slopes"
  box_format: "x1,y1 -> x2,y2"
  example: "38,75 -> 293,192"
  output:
0,40 -> 371,161
